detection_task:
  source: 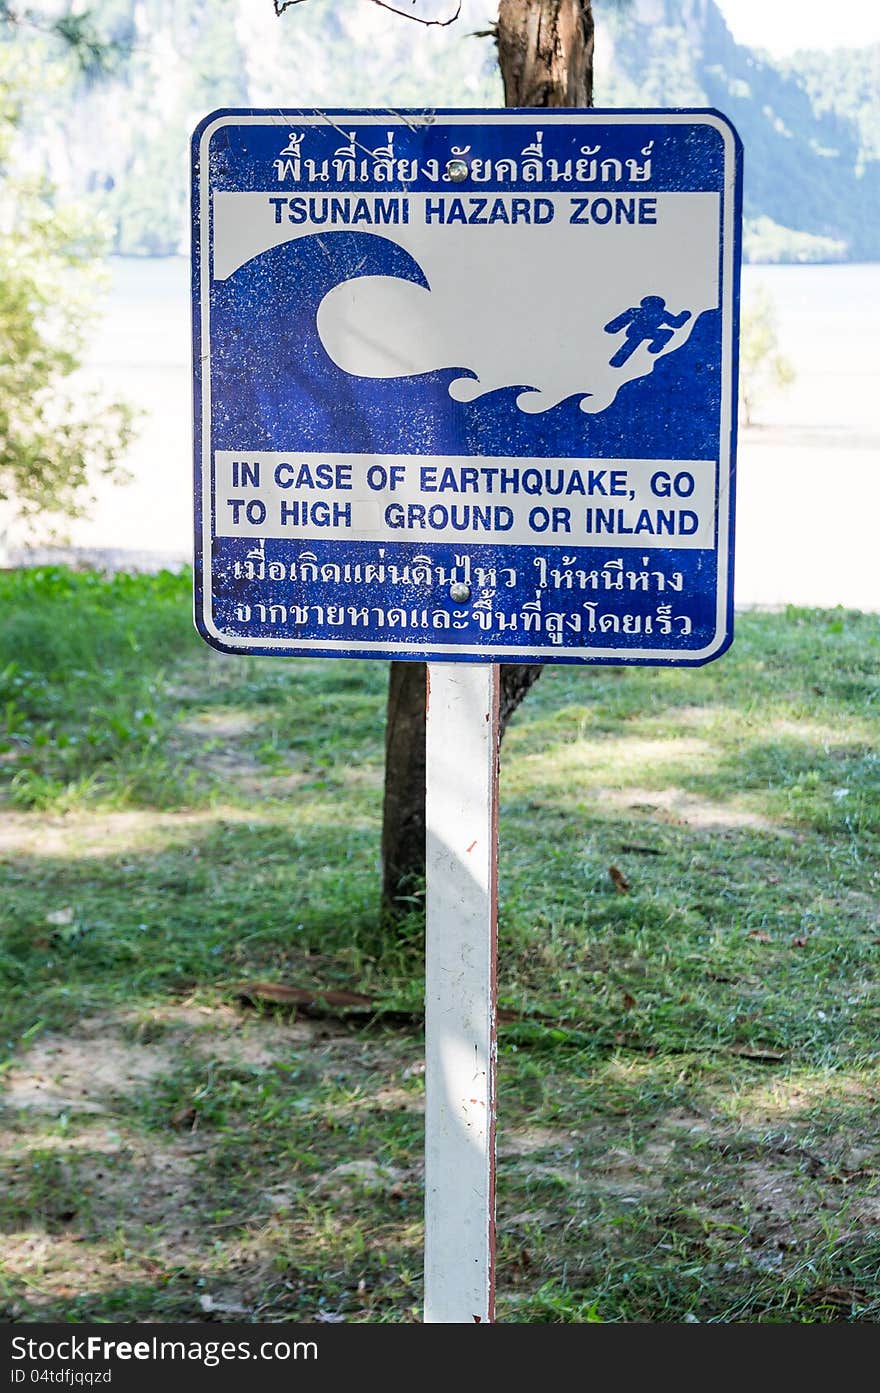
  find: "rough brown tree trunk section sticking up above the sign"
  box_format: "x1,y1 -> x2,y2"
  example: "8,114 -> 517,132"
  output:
497,0 -> 593,107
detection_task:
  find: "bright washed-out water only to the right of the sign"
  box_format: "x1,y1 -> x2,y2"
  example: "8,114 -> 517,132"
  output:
734,263 -> 880,610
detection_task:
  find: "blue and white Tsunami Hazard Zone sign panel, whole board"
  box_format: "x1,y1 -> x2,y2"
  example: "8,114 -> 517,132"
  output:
192,110 -> 742,664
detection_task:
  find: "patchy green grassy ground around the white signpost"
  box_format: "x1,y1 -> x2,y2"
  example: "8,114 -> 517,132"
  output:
0,570 -> 880,1323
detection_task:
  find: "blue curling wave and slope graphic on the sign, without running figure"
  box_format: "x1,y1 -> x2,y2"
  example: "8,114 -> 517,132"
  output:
210,231 -> 721,458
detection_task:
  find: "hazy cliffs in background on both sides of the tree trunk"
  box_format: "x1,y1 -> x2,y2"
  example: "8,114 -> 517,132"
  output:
0,0 -> 880,260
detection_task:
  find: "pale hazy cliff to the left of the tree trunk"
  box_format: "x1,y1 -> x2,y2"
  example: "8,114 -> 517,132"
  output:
41,0 -> 503,256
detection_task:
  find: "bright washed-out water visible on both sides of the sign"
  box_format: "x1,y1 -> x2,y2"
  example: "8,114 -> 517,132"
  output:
32,258 -> 880,610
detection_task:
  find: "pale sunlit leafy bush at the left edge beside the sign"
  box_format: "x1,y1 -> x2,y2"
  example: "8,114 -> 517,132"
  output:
0,40 -> 134,534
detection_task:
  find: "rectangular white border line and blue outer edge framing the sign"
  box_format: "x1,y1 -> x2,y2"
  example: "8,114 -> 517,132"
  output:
196,107 -> 737,666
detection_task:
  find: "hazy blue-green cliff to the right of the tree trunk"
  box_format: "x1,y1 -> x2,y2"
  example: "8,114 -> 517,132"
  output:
593,0 -> 880,260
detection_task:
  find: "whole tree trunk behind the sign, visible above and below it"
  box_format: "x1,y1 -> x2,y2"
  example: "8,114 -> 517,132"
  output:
382,0 -> 593,915
